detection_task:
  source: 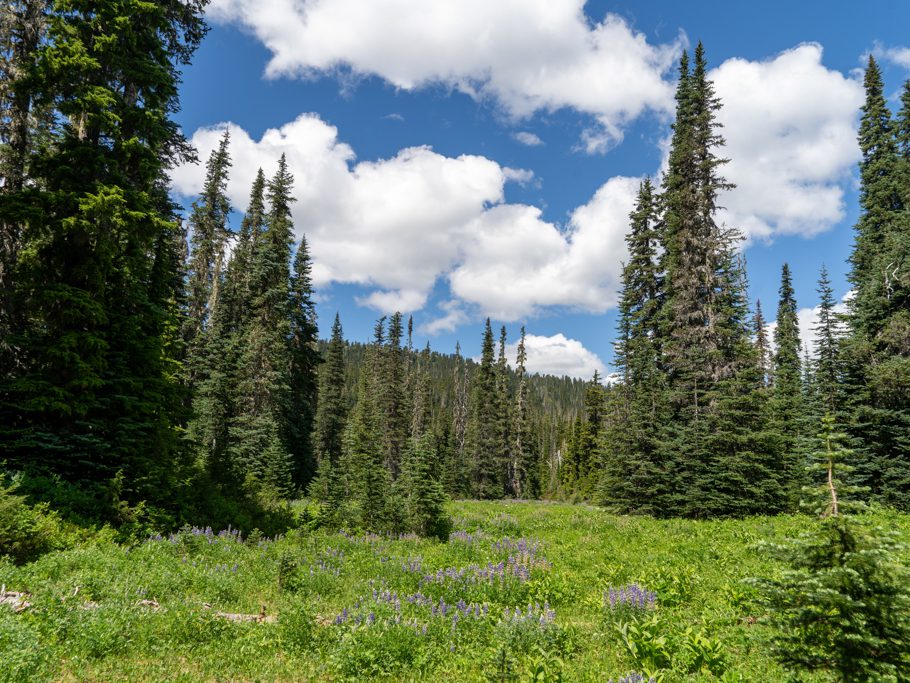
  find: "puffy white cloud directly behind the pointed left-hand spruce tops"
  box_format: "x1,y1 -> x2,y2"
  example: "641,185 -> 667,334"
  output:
172,115 -> 528,312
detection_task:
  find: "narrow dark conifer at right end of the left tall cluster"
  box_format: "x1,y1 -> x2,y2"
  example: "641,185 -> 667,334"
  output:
286,237 -> 321,487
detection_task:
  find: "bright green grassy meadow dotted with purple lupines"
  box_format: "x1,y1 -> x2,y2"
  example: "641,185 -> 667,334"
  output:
0,502 -> 910,682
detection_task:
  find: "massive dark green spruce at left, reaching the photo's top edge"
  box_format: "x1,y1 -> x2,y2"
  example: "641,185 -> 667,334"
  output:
0,0 -> 205,503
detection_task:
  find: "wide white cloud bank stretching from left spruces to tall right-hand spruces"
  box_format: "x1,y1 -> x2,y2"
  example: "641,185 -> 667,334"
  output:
172,115 -> 638,322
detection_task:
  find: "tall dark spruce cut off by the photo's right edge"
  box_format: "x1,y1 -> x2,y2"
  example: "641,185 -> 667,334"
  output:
841,57 -> 910,509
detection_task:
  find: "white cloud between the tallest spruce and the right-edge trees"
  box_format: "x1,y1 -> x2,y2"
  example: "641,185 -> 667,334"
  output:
710,44 -> 863,239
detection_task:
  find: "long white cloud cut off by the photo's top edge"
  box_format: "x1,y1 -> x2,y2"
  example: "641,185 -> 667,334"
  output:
209,0 -> 681,149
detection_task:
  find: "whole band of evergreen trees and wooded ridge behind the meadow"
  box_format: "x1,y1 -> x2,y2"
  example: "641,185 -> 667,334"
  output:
0,0 -> 910,536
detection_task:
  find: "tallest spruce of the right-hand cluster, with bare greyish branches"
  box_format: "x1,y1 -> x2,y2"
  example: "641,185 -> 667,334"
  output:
660,43 -> 764,516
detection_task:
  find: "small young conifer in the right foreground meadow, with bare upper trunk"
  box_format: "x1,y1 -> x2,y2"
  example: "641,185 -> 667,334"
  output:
755,416 -> 910,683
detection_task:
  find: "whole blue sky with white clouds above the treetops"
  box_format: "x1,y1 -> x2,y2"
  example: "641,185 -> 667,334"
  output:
172,0 -> 910,377
